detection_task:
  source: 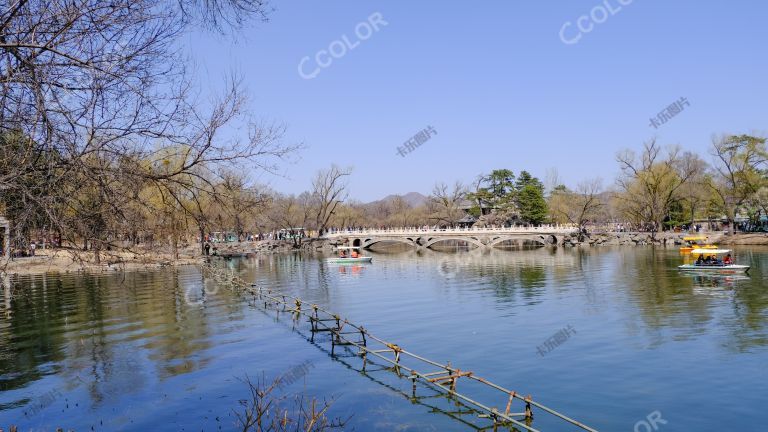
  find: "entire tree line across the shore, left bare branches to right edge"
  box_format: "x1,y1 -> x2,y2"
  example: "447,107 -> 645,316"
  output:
0,0 -> 768,261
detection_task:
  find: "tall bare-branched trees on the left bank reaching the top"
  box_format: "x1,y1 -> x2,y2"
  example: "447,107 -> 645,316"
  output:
0,0 -> 296,259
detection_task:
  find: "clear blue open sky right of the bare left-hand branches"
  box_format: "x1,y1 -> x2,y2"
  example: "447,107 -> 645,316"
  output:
186,0 -> 768,202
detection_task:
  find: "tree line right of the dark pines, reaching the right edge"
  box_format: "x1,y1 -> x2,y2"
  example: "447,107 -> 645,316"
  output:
550,135 -> 768,233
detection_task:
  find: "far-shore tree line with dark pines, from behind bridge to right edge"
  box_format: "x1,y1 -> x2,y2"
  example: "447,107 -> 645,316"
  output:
312,135 -> 768,238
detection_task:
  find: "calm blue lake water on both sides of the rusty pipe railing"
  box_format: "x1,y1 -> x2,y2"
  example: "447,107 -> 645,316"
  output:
0,248 -> 768,431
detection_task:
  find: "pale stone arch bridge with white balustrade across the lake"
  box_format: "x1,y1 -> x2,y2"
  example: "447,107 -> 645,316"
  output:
325,226 -> 578,249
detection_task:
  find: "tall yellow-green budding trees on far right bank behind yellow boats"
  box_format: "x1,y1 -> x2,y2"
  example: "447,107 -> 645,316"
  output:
614,135 -> 768,233
